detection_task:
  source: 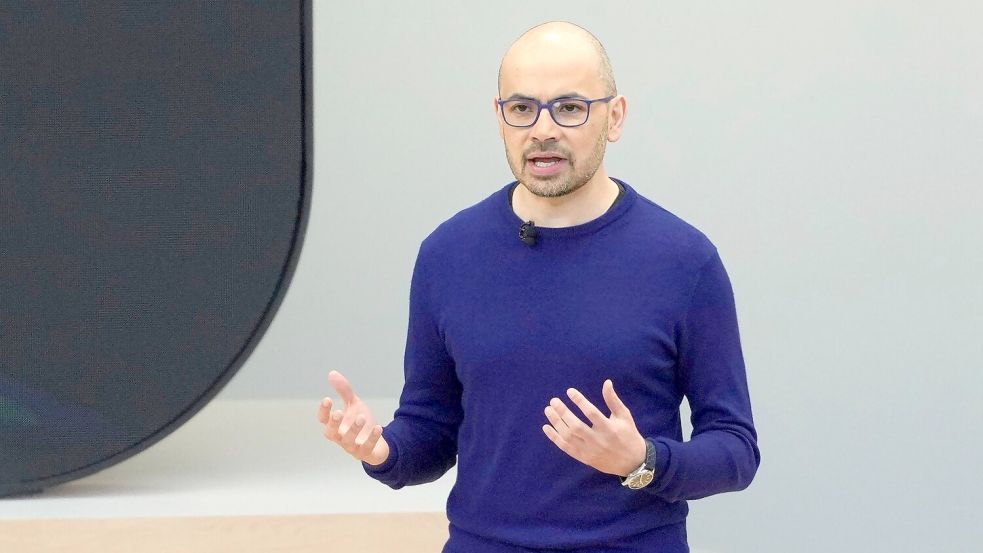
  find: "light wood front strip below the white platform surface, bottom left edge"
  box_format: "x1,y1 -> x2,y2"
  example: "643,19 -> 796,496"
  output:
0,513 -> 447,553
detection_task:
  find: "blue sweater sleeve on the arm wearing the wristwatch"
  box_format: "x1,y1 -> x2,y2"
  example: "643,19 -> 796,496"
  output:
643,248 -> 761,501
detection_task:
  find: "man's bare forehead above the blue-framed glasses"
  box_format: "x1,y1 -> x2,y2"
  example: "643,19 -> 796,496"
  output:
499,44 -> 603,99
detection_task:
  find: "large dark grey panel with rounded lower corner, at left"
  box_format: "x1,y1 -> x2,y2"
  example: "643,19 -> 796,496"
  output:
0,0 -> 312,495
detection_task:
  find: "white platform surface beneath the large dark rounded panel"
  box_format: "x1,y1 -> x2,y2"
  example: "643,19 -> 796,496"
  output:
0,395 -> 456,519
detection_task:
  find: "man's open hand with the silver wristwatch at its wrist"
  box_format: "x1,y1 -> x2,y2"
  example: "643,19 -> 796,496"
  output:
543,379 -> 645,476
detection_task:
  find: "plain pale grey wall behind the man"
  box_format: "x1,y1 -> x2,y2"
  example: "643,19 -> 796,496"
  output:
222,0 -> 983,552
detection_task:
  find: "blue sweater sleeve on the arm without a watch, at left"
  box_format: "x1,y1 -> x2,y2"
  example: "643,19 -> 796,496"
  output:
362,241 -> 463,489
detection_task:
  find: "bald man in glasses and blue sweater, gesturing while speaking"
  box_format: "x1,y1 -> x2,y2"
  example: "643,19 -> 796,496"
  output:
318,22 -> 760,553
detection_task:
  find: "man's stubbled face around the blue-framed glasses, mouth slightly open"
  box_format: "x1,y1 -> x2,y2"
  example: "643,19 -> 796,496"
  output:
495,45 -> 609,197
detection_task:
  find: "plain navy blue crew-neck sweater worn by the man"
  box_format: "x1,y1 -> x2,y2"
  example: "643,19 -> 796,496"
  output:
363,179 -> 760,553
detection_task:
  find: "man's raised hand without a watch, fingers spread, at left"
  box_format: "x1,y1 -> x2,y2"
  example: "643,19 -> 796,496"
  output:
317,371 -> 389,465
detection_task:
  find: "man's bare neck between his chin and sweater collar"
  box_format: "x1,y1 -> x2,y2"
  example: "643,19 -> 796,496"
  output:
512,168 -> 620,227
